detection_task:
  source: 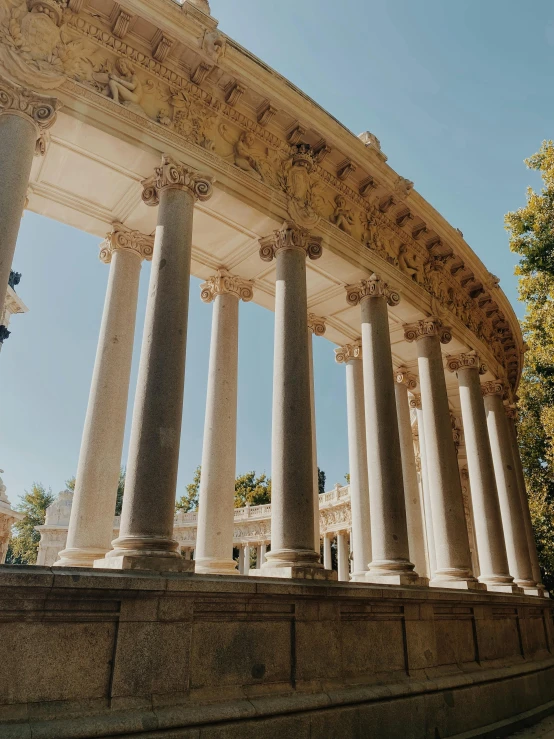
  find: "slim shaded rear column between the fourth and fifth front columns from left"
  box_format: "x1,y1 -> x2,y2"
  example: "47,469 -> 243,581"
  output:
394,367 -> 429,584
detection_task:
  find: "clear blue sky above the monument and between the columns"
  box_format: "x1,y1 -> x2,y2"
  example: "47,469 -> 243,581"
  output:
0,0 -> 554,502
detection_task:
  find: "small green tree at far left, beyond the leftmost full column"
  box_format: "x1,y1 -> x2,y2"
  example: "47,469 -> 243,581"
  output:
6,482 -> 54,565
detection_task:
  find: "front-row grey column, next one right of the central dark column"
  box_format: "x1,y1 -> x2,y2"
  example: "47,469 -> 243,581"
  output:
346,275 -> 419,585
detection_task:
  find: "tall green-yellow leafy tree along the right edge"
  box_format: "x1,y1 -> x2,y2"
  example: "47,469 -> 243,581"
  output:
506,146 -> 554,589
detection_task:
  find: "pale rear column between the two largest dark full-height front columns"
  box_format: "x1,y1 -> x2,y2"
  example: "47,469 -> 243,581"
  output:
195,269 -> 253,575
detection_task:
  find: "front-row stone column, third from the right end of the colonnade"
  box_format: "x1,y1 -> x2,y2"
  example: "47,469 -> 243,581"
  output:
446,352 -> 521,593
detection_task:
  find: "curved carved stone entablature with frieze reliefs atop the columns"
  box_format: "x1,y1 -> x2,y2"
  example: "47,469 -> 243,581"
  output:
0,0 -> 524,390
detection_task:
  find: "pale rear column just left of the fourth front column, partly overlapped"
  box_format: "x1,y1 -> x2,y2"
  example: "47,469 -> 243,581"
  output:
335,340 -> 371,581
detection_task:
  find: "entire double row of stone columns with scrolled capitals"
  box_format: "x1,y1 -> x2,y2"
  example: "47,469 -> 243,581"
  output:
0,86 -> 542,593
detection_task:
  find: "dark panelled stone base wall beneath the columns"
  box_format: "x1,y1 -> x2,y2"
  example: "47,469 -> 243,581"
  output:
0,566 -> 554,739
